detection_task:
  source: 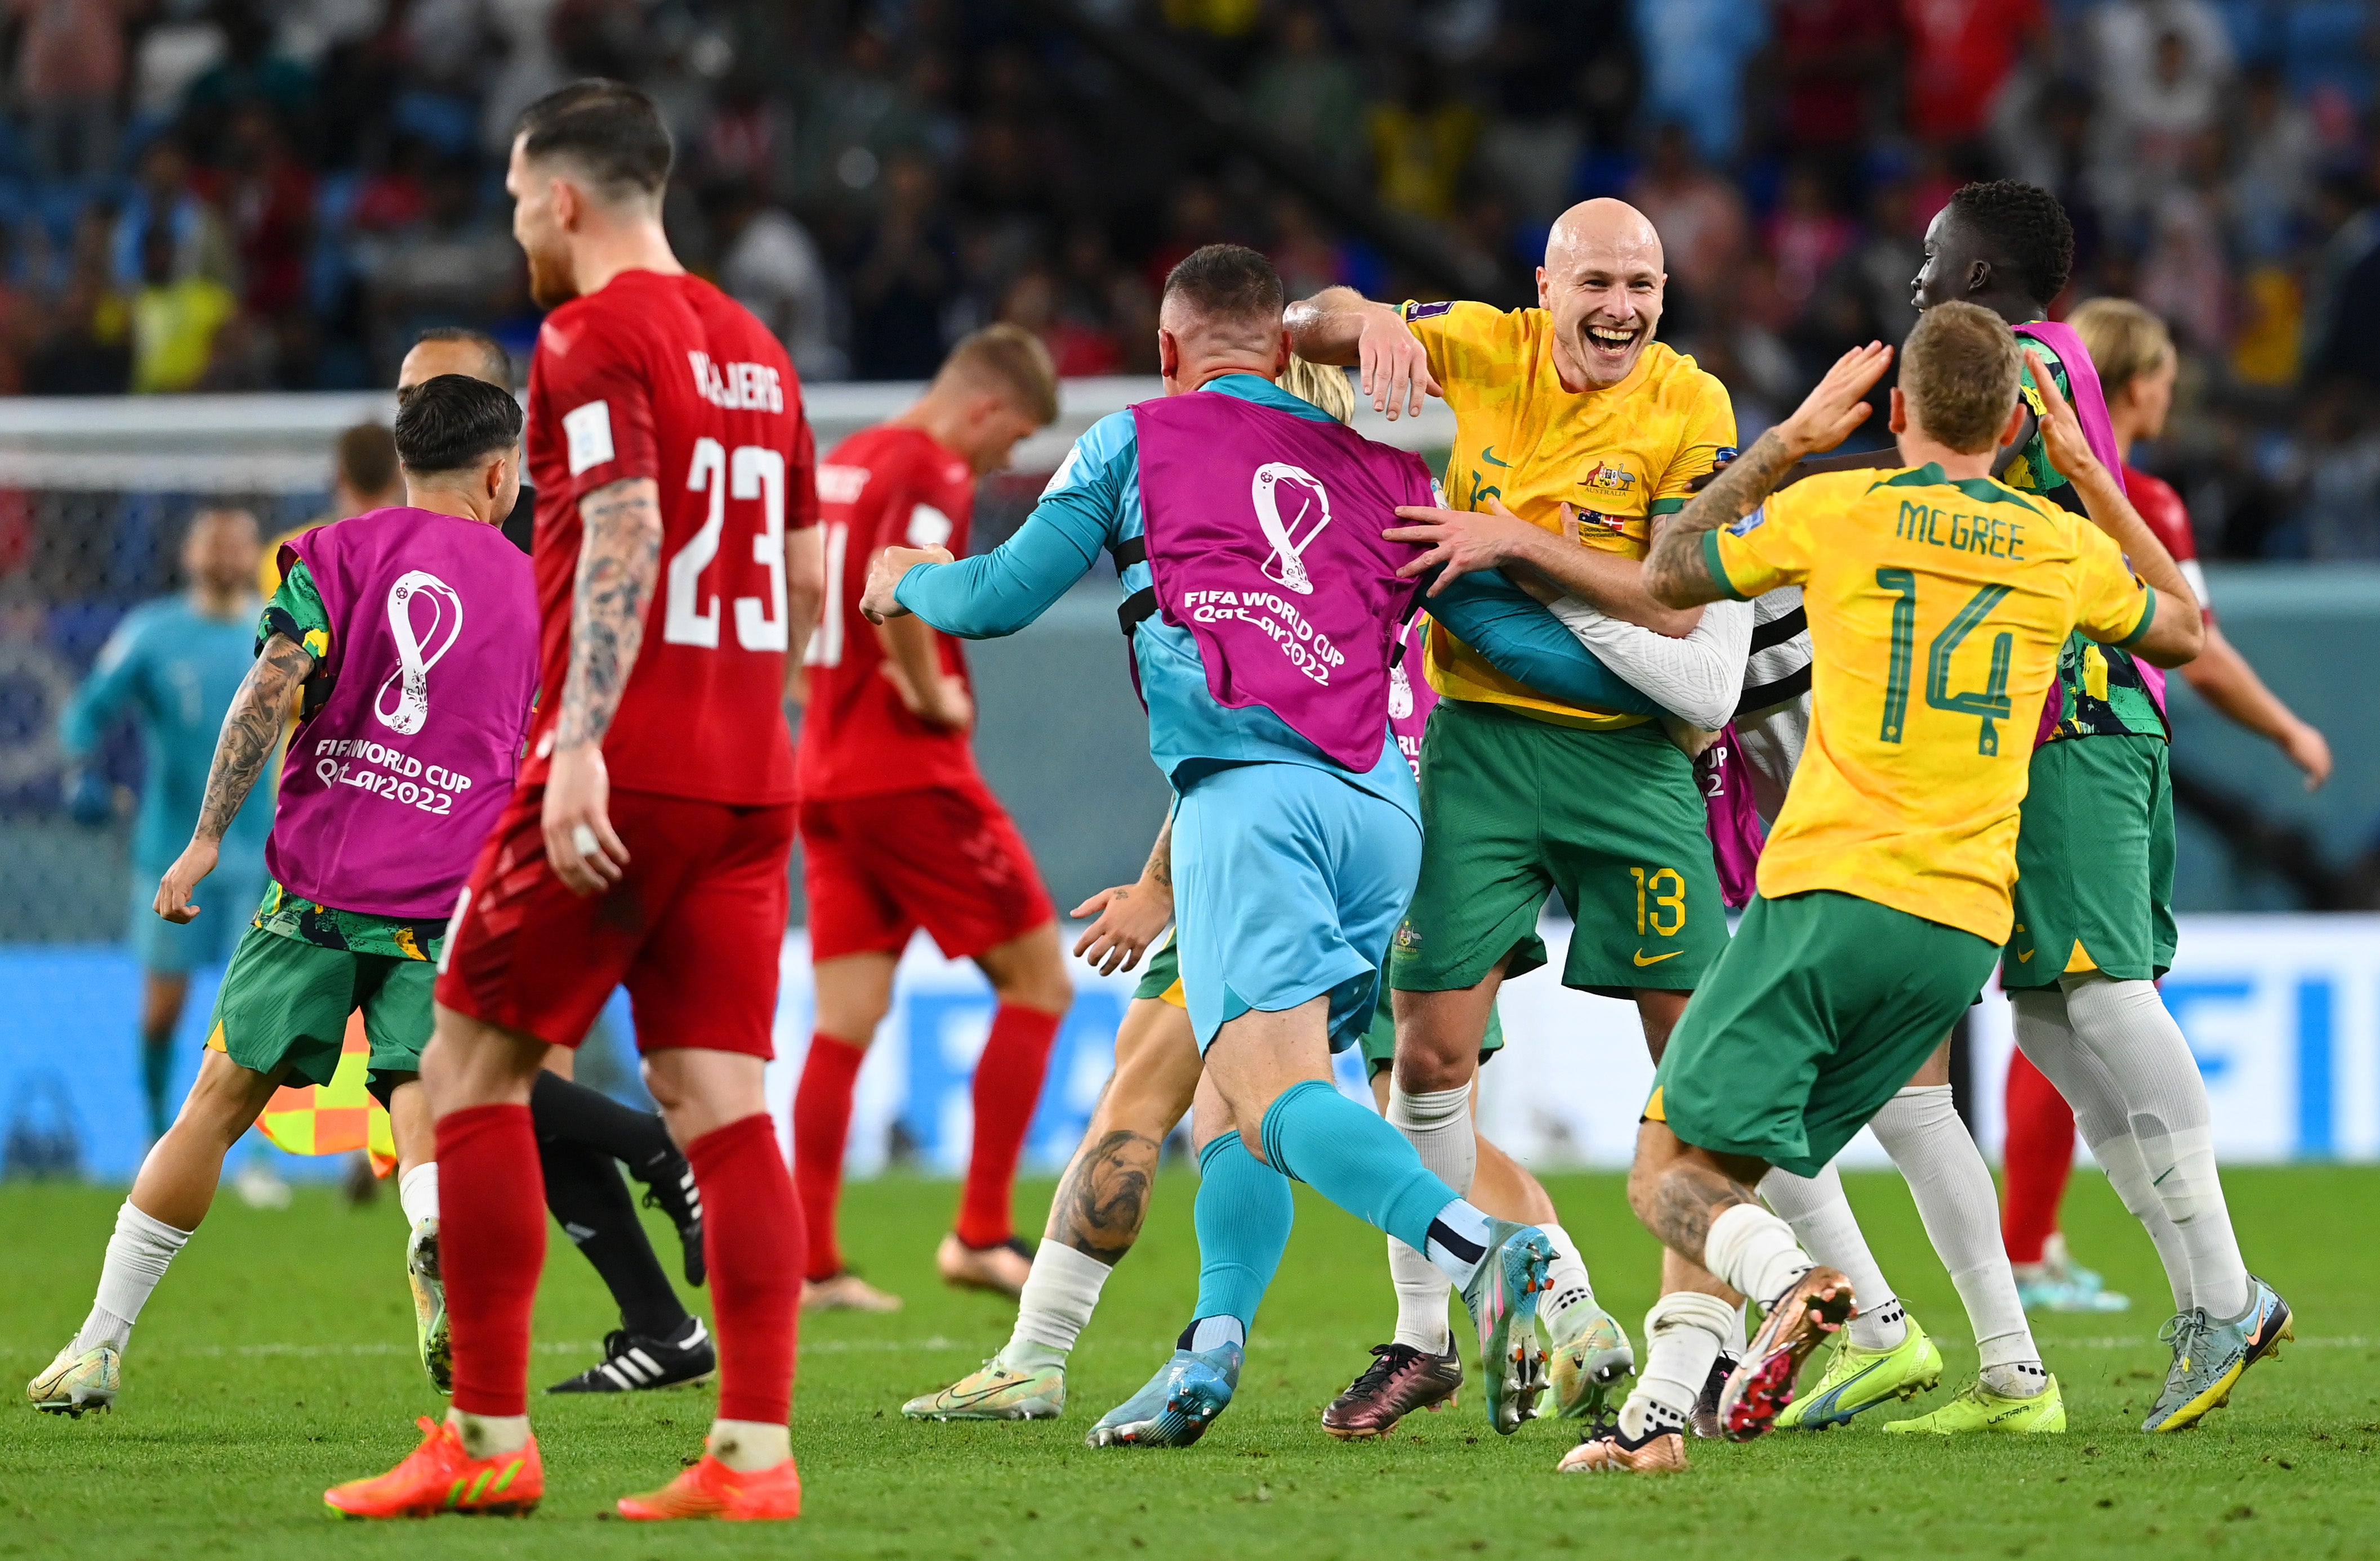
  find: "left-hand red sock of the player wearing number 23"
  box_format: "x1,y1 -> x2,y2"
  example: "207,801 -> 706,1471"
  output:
438,1107 -> 547,1416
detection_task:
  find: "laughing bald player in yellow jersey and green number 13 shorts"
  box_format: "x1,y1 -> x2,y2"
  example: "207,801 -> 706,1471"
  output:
1287,200 -> 1749,1437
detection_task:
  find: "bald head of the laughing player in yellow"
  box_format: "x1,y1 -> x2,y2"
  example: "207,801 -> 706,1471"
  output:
1537,200 -> 1668,393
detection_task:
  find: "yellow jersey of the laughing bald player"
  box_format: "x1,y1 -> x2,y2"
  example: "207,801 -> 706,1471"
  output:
1404,302 -> 1735,728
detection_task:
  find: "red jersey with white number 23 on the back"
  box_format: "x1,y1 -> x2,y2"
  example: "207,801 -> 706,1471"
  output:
521,271 -> 819,806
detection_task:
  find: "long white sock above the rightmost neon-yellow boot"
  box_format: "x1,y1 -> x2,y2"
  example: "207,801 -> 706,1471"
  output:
1868,1085 -> 2047,1397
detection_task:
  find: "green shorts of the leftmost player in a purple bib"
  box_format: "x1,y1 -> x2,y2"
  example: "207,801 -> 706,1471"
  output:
207,928 -> 438,1107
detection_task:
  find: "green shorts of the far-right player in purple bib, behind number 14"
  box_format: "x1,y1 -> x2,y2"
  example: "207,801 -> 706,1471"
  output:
1999,735 -> 2176,988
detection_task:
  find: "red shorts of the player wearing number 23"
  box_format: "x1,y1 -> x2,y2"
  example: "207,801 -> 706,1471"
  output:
438,785 -> 792,1056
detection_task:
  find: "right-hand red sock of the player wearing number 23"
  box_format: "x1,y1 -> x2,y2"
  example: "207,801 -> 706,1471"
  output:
685,1111 -> 802,1425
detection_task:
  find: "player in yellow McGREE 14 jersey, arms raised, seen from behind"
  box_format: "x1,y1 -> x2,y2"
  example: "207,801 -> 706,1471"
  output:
1573,302 -> 2201,1468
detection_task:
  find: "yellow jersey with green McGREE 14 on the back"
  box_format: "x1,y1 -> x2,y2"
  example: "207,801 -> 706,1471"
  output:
1702,464 -> 2156,942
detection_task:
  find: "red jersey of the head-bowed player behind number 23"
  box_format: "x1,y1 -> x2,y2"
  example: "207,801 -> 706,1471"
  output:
797,423 -> 976,800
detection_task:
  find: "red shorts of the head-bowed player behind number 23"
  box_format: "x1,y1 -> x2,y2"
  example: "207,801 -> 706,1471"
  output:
802,780 -> 1057,959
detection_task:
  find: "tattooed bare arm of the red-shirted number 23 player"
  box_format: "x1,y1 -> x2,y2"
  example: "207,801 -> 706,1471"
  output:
545,476 -> 662,895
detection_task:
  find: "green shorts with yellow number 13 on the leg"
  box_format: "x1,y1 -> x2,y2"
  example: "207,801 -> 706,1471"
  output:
1388,699 -> 1728,997
